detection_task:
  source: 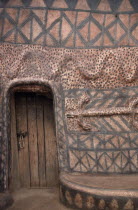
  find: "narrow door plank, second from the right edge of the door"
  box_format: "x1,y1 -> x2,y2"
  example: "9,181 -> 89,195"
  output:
36,96 -> 46,187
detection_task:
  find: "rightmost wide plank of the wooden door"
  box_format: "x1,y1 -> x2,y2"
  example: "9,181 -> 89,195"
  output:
44,99 -> 58,187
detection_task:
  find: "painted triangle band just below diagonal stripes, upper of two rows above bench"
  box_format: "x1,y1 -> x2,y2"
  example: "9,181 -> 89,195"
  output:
68,133 -> 138,151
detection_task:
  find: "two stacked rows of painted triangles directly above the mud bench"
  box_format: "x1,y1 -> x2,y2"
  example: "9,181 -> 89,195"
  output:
68,134 -> 138,173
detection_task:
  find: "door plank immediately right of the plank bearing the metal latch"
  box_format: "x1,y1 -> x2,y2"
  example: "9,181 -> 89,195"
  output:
27,94 -> 39,187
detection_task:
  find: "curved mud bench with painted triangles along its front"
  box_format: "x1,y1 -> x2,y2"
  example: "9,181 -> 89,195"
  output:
60,173 -> 138,210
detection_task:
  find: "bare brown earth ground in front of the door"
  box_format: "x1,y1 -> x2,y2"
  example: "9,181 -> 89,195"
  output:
8,189 -> 72,210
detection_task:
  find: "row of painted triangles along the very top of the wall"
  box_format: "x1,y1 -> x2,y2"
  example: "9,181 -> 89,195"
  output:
0,0 -> 138,12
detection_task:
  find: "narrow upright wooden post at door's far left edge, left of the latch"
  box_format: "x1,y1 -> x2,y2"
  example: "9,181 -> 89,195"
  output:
10,94 -> 20,190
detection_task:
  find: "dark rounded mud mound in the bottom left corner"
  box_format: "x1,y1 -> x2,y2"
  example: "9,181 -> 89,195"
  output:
0,193 -> 13,210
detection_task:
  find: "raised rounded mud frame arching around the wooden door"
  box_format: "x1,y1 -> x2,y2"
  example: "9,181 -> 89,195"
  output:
0,78 -> 67,190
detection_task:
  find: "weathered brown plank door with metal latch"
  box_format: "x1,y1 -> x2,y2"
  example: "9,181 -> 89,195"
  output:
11,93 -> 58,187
